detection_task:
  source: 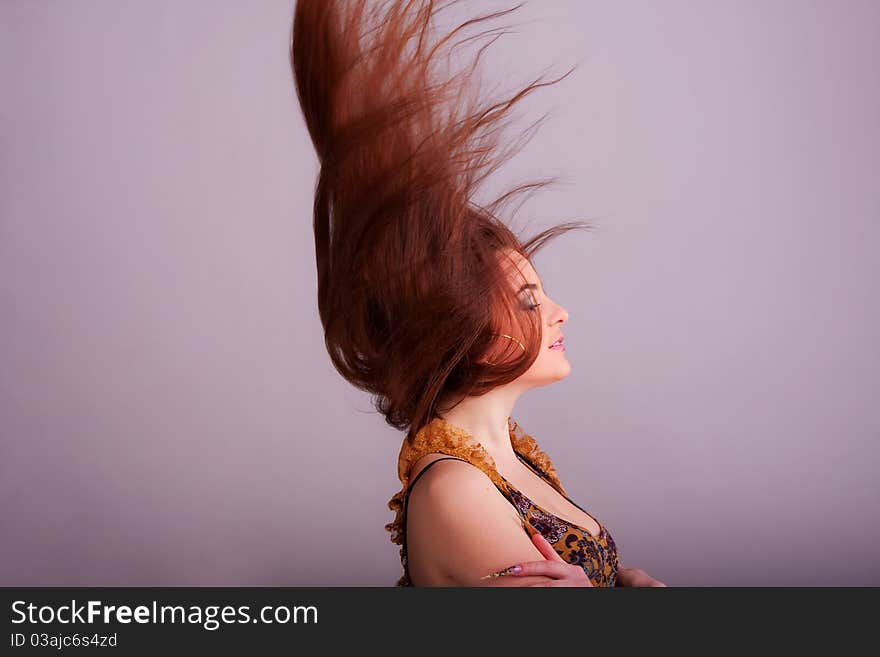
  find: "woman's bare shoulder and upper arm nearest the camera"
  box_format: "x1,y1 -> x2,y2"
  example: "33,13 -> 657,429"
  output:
406,454 -> 549,586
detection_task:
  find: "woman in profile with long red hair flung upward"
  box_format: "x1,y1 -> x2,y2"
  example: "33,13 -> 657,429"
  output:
290,0 -> 664,586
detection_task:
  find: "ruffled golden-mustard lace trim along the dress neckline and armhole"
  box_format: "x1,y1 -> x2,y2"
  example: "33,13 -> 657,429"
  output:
385,417 -> 566,586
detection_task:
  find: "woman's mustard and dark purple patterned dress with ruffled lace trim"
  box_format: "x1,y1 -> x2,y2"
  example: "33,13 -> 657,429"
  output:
385,417 -> 619,587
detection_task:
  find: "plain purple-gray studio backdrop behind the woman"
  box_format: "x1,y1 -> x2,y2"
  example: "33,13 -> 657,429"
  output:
0,0 -> 880,586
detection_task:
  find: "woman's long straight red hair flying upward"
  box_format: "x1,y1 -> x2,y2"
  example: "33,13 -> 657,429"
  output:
290,0 -> 592,439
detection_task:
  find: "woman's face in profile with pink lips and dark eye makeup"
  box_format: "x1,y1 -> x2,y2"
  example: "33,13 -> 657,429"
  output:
488,251 -> 571,388
